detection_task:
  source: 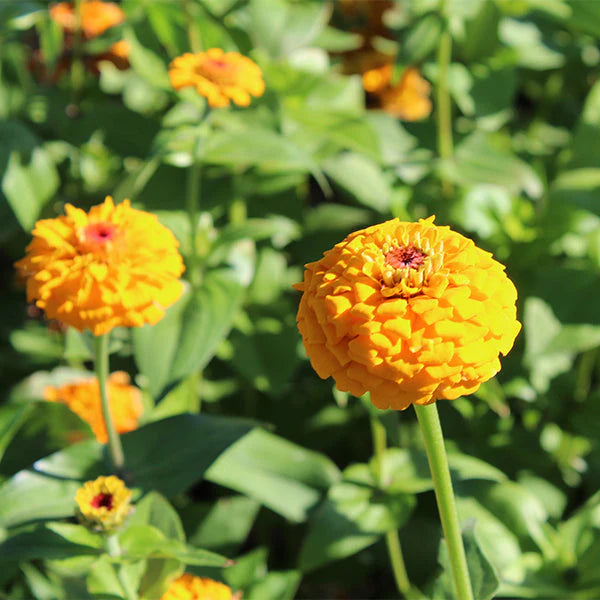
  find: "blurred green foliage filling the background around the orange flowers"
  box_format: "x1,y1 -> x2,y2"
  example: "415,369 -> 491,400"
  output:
0,0 -> 600,600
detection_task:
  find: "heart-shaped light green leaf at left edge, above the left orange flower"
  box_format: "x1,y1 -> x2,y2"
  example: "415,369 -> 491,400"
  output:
2,148 -> 59,231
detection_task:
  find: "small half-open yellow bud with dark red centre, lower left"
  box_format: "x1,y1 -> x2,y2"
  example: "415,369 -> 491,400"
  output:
75,475 -> 131,531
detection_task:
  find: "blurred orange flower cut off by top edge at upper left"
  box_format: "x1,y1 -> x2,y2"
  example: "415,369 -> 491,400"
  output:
50,0 -> 125,39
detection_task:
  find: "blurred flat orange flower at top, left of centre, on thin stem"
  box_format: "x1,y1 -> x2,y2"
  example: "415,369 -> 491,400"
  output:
169,48 -> 265,107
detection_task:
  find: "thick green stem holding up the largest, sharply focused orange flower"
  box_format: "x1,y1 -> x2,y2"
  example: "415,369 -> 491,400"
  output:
414,402 -> 473,600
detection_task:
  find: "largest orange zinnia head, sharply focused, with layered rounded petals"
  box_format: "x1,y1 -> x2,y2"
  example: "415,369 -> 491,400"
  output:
295,217 -> 521,410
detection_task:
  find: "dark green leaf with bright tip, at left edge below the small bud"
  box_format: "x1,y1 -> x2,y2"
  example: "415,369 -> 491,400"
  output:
0,523 -> 103,562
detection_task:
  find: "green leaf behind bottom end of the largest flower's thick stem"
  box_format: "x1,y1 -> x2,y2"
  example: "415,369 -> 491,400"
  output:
432,527 -> 500,600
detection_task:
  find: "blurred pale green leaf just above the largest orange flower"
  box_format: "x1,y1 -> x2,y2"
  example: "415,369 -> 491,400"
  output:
323,152 -> 391,213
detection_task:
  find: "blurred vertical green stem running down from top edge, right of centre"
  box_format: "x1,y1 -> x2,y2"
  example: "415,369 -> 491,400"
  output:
436,0 -> 454,196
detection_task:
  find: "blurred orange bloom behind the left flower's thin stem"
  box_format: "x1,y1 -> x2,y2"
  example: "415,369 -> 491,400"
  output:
44,371 -> 142,444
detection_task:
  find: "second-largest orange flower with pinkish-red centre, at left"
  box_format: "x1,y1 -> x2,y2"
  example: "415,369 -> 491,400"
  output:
15,196 -> 184,335
